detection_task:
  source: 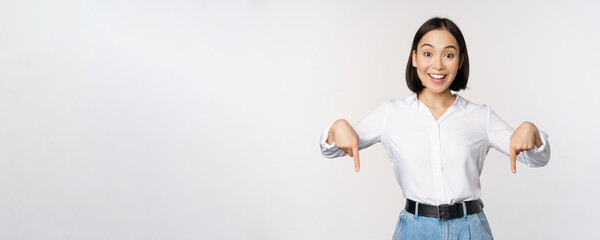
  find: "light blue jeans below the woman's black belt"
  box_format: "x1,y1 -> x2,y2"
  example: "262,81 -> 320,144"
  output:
392,210 -> 494,240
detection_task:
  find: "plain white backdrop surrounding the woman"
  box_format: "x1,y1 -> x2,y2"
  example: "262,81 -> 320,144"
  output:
0,0 -> 600,240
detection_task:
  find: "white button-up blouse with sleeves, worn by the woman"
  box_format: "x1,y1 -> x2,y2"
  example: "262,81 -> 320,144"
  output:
321,93 -> 550,205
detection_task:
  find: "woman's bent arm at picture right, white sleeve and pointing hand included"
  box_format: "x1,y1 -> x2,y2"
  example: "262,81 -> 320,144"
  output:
487,107 -> 550,173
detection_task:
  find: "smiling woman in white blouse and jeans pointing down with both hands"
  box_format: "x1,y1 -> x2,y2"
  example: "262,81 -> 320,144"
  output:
321,18 -> 550,239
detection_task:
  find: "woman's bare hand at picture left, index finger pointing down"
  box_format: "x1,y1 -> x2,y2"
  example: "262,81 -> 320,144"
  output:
327,119 -> 360,172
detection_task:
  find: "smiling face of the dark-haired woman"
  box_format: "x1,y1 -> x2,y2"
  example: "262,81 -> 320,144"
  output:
412,29 -> 464,93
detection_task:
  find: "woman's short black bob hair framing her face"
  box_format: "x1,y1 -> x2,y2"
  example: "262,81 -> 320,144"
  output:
406,17 -> 469,93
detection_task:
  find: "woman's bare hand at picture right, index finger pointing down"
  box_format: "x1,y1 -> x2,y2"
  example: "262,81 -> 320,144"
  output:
510,122 -> 542,173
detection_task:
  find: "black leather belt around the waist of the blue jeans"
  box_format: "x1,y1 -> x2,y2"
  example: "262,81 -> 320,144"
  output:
404,199 -> 483,221
